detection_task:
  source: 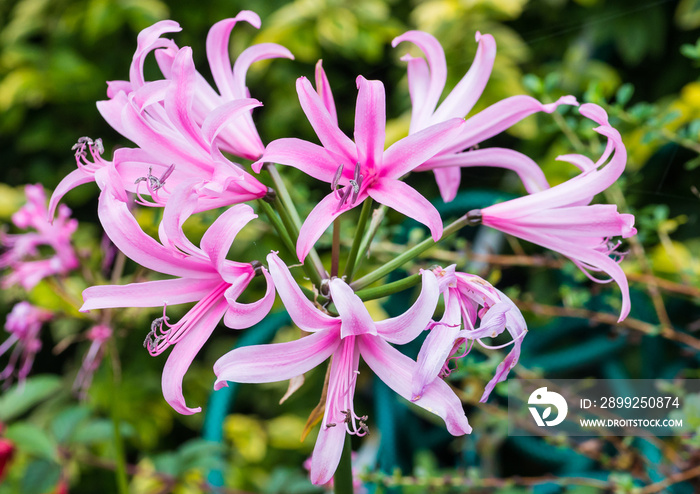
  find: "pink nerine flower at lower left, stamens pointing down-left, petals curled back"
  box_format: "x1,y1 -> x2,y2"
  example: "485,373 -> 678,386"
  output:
80,168 -> 275,414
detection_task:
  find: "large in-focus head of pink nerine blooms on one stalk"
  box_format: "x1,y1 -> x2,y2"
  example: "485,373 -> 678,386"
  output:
35,11 -> 635,484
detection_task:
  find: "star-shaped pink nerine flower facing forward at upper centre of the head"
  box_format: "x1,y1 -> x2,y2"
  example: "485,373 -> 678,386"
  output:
253,66 -> 464,260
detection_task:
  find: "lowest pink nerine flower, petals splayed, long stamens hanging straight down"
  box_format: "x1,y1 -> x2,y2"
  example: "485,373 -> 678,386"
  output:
214,253 -> 471,484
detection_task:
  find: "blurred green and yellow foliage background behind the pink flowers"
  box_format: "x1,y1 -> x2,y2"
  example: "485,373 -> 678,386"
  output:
0,0 -> 700,494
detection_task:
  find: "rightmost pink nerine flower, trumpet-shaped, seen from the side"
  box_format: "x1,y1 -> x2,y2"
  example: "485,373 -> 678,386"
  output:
467,103 -> 637,321
